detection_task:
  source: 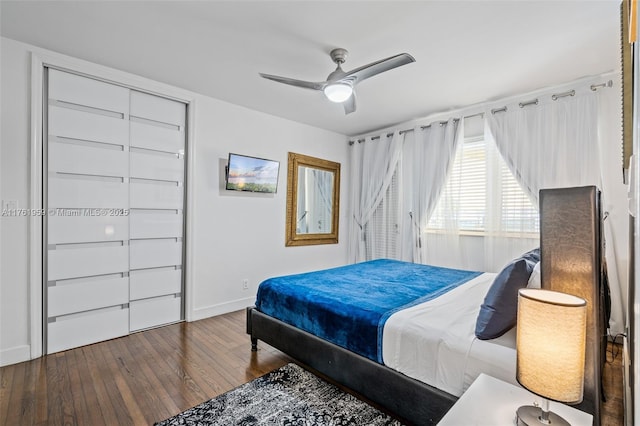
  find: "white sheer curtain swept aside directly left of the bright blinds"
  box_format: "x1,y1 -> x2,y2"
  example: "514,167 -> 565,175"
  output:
402,118 -> 461,266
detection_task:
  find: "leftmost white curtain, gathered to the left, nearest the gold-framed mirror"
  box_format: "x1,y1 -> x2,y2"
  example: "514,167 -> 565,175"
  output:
348,131 -> 404,262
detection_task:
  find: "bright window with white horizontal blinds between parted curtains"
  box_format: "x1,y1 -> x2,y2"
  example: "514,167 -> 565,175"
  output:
427,128 -> 539,236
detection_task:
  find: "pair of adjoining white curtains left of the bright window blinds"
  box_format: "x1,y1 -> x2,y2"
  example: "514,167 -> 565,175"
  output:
349,119 -> 460,263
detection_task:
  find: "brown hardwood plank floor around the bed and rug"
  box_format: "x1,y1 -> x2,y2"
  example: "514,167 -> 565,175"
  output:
0,311 -> 623,426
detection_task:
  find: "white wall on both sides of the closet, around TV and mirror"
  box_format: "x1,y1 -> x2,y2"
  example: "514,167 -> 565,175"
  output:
0,38 -> 348,365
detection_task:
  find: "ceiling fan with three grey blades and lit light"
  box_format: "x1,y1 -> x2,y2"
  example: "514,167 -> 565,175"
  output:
260,48 -> 415,114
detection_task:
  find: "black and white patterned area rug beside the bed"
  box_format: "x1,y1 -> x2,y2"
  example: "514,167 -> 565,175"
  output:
156,364 -> 401,426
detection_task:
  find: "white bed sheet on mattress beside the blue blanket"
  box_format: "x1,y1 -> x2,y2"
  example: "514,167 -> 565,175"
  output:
382,273 -> 517,396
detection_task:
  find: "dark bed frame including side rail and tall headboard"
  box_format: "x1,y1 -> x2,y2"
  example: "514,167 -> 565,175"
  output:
247,187 -> 606,425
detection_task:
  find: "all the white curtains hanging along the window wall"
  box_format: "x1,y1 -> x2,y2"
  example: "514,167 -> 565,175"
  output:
349,77 -> 629,333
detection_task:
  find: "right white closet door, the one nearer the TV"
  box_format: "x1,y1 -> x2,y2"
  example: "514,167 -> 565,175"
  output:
129,91 -> 186,330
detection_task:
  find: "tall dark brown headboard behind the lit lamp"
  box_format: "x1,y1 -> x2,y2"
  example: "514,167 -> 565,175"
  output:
540,186 -> 606,425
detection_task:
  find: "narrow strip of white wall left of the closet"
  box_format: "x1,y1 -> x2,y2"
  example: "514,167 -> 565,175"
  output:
0,38 -> 31,364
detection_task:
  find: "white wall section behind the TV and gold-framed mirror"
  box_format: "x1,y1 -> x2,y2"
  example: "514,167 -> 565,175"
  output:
191,90 -> 348,319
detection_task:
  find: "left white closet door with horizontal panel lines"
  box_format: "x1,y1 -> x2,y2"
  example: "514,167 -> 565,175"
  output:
46,70 -> 129,353
